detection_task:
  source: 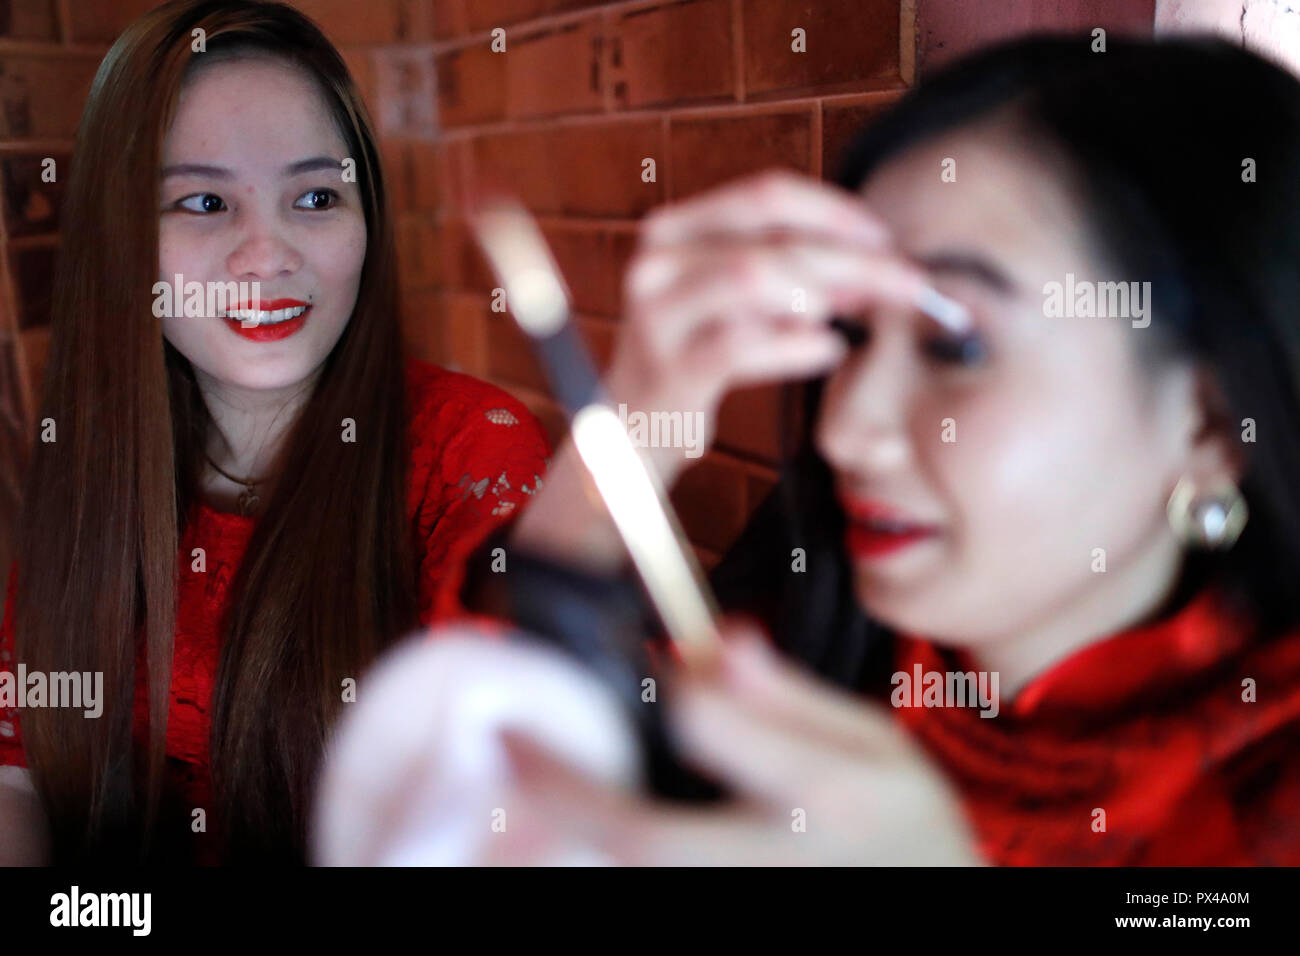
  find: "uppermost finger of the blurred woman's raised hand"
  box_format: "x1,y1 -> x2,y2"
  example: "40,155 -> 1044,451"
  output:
641,170 -> 888,248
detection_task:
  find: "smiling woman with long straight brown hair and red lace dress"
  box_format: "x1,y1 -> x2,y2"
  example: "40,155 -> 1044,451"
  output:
0,0 -> 549,861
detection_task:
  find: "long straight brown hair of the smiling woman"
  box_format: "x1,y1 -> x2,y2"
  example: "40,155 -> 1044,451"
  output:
14,0 -> 416,861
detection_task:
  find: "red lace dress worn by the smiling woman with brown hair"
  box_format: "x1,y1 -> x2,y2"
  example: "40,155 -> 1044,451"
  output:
0,359 -> 550,862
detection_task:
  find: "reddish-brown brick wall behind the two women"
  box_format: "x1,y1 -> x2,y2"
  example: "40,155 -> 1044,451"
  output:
0,0 -> 1153,580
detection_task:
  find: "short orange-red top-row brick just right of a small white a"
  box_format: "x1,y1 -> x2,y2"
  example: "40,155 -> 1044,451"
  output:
495,20 -> 603,117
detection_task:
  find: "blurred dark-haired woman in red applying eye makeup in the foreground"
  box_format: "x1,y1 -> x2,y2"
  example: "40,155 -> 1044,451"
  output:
465,38 -> 1300,865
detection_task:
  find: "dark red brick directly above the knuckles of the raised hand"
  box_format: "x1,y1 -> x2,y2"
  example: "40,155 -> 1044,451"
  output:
670,109 -> 813,199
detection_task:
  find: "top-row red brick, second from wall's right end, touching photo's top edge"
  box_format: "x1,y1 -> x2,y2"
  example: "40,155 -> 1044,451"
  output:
611,0 -> 736,108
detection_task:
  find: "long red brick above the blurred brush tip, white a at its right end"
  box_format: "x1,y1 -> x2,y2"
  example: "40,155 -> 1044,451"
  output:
468,120 -> 663,219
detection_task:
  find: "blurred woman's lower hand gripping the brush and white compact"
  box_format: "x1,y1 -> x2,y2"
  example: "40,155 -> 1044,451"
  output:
485,626 -> 982,865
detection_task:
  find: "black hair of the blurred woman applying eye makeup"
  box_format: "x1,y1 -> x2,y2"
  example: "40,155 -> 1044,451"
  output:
712,36 -> 1300,689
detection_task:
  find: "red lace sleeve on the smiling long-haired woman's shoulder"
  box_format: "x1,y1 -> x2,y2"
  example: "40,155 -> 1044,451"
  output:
412,373 -> 550,624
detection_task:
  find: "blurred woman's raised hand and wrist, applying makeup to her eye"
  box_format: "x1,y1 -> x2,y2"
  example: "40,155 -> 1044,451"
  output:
514,172 -> 926,571
